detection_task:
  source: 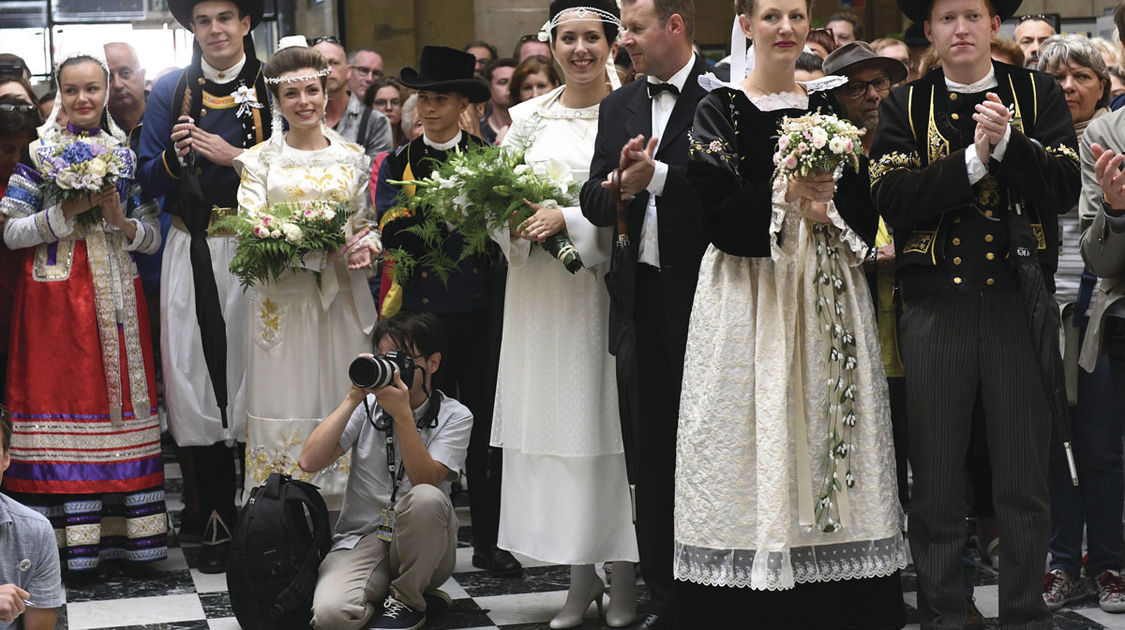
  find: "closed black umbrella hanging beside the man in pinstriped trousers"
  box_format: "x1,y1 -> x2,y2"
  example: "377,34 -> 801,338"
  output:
1008,204 -> 1078,486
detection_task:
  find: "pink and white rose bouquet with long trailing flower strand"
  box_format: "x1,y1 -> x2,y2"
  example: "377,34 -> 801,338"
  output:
773,113 -> 863,532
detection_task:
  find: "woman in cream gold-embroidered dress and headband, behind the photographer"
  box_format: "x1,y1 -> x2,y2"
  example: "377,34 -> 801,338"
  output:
234,36 -> 381,503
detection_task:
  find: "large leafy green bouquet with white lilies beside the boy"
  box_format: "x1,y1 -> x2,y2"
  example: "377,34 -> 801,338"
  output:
388,145 -> 582,284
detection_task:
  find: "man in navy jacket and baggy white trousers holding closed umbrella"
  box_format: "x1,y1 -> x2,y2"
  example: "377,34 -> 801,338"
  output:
137,0 -> 270,573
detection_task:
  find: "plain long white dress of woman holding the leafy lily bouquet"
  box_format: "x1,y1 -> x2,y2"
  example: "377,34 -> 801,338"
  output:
492,88 -> 638,565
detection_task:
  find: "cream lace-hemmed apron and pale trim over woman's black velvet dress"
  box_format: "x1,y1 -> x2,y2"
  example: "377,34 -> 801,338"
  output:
674,87 -> 906,591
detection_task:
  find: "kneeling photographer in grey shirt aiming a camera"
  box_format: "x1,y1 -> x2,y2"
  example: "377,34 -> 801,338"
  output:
298,312 -> 473,630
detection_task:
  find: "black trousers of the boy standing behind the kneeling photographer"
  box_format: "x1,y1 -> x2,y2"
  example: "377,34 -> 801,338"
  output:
434,308 -> 501,549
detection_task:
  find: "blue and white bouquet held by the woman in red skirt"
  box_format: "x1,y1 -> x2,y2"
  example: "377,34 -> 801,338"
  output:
38,140 -> 133,225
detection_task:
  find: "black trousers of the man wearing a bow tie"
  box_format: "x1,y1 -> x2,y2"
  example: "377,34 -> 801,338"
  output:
635,264 -> 687,615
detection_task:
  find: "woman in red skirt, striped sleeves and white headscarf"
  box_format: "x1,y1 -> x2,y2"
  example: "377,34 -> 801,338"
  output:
0,47 -> 168,570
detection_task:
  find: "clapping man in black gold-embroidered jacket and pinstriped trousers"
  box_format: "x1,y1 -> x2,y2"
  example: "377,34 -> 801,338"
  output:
871,0 -> 1080,630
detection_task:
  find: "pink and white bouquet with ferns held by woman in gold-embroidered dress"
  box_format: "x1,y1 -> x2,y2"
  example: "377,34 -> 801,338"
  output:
209,200 -> 348,289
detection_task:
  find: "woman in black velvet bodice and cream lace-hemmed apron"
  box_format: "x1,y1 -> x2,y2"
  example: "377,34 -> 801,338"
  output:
674,0 -> 906,629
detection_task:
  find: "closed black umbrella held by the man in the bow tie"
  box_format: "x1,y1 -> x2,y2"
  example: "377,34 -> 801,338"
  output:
605,170 -> 640,520
